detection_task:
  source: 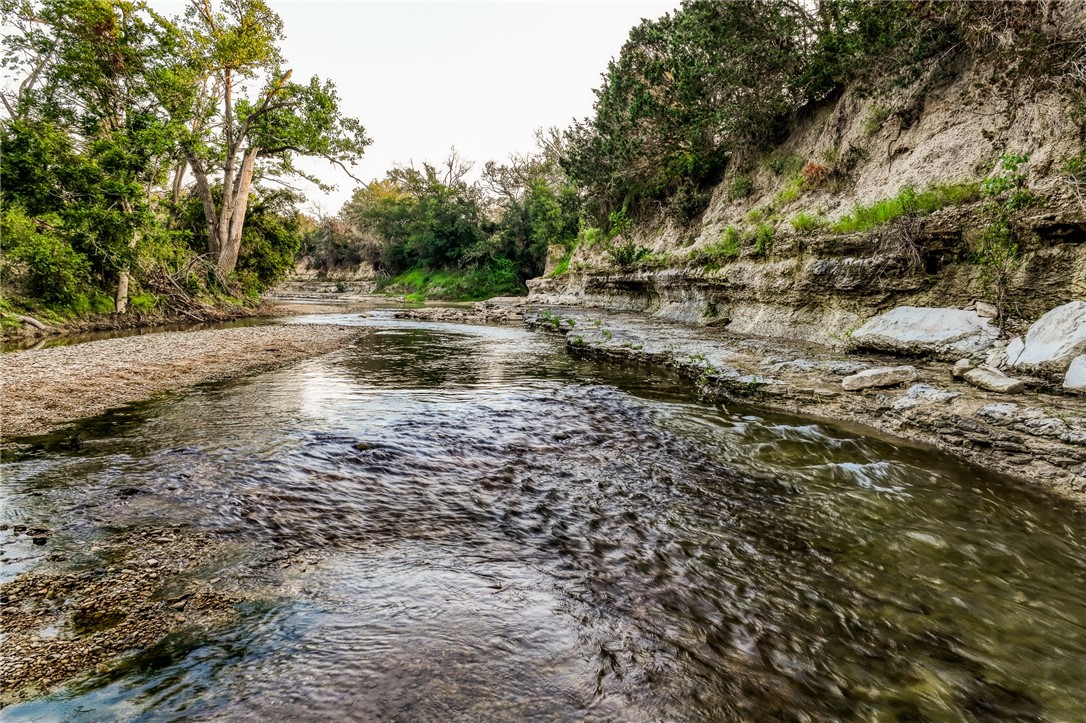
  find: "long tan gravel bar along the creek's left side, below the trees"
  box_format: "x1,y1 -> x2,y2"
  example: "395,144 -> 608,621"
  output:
0,325 -> 358,439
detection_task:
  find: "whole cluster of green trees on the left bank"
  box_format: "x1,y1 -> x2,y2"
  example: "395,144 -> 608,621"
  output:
0,0 -> 369,312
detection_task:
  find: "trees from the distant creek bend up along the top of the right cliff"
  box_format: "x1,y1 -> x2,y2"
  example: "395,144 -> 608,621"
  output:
306,0 -> 1086,293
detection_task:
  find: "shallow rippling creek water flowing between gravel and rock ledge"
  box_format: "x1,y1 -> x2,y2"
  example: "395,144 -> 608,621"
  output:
0,313 -> 1086,721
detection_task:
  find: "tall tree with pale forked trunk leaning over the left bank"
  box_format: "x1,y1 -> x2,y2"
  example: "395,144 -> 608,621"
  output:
174,0 -> 370,272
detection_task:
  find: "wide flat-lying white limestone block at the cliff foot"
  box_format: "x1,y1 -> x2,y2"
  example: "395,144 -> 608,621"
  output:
851,306 -> 999,357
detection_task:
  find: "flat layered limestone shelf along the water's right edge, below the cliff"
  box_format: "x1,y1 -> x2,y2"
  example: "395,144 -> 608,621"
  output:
399,300 -> 1086,505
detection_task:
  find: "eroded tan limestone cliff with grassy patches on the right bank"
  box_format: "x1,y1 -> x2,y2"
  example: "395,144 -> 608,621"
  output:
529,33 -> 1086,346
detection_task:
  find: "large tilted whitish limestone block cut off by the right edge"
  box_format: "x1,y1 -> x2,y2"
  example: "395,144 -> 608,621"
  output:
1007,301 -> 1086,377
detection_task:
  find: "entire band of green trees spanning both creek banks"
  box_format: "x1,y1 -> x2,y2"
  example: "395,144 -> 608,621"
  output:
0,0 -> 1086,310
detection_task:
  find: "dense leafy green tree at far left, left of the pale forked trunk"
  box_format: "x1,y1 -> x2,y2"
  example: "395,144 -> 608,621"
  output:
3,0 -> 182,312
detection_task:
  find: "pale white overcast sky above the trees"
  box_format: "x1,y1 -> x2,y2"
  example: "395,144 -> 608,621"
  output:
152,0 -> 679,213
